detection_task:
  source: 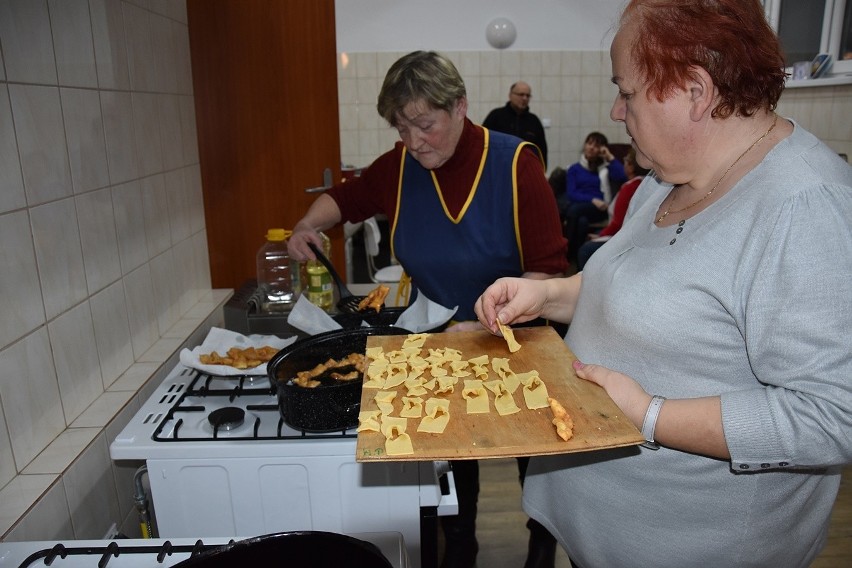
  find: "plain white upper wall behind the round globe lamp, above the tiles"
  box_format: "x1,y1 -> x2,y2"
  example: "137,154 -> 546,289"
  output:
335,0 -> 625,52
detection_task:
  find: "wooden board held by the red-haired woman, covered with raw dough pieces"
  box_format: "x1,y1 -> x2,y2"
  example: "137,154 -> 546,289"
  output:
356,327 -> 644,462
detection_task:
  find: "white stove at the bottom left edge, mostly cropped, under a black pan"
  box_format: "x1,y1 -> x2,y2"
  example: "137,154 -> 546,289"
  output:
0,532 -> 409,568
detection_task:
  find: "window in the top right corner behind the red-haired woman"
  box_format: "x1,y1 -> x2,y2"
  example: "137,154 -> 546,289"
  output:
763,0 -> 852,75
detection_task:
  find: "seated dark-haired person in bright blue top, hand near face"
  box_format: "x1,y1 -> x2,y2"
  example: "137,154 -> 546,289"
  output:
556,132 -> 627,261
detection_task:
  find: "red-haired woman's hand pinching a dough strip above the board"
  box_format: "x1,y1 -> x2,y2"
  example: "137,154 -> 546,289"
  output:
473,278 -> 548,335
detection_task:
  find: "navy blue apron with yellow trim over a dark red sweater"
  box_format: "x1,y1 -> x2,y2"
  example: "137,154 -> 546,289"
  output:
391,129 -> 535,321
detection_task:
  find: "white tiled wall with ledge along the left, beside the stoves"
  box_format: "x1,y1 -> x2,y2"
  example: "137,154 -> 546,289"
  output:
0,0 -> 223,540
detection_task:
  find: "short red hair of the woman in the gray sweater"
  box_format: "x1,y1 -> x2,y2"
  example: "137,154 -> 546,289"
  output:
621,0 -> 787,118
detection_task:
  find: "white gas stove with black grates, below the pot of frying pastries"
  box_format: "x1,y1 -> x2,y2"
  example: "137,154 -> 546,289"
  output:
110,365 -> 458,568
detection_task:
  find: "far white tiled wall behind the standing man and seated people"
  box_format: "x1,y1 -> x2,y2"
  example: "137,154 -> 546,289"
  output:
337,50 -> 852,170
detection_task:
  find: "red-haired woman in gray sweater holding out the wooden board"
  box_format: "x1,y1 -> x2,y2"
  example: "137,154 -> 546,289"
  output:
476,0 -> 852,568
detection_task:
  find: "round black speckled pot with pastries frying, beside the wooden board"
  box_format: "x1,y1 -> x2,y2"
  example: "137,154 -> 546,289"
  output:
266,327 -> 411,432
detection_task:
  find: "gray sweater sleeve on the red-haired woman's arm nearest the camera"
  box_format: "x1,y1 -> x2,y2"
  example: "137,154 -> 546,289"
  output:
722,178 -> 852,471
